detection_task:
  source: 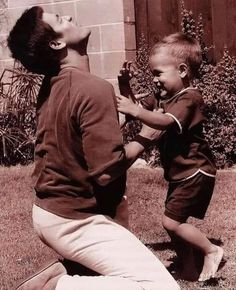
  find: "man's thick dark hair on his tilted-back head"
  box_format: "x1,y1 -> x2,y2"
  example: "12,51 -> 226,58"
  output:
7,6 -> 59,75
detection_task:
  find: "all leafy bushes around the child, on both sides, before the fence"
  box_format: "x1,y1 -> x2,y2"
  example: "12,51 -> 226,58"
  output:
124,1 -> 236,168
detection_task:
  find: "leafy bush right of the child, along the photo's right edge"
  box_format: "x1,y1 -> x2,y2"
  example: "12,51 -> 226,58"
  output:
181,1 -> 236,168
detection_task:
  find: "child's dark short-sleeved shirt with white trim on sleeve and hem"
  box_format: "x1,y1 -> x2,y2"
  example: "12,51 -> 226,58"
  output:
159,88 -> 216,181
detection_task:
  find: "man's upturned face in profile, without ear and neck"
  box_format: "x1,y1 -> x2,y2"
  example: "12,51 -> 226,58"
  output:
42,12 -> 91,46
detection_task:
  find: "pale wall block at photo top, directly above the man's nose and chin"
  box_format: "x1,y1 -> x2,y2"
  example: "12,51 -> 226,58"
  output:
76,0 -> 124,26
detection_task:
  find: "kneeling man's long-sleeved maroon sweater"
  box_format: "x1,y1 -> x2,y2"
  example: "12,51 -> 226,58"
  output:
33,67 -> 126,218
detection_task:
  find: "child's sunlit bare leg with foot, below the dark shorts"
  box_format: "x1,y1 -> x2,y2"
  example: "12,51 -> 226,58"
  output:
163,216 -> 223,281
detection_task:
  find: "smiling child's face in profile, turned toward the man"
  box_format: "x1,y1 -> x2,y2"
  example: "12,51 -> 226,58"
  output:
149,48 -> 184,98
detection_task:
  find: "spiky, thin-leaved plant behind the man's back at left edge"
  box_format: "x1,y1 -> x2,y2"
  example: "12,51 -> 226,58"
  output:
0,62 -> 41,166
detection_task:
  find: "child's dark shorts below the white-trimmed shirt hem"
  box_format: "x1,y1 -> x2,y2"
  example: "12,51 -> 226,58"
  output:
165,172 -> 215,222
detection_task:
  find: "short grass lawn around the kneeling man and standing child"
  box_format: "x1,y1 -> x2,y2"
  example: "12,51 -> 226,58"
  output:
0,166 -> 236,290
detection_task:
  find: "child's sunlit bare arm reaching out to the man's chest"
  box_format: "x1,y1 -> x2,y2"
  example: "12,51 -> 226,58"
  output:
117,96 -> 174,130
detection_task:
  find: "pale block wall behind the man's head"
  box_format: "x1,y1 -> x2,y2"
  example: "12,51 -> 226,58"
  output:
0,0 -> 136,92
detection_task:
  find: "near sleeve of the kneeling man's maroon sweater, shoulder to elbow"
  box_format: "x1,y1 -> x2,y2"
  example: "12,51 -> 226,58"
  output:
77,80 -> 125,179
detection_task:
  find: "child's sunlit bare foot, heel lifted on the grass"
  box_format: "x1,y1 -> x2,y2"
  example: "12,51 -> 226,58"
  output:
198,245 -> 224,281
